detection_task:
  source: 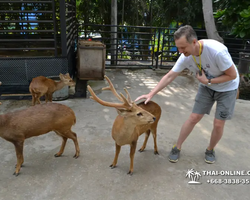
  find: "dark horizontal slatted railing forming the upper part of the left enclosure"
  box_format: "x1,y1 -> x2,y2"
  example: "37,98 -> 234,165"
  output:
0,0 -> 77,57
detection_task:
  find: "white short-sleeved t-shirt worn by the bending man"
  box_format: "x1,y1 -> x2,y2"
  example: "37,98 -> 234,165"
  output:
172,39 -> 239,92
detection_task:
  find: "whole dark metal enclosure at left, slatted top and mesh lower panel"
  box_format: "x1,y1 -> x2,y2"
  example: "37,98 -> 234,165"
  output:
0,0 -> 77,94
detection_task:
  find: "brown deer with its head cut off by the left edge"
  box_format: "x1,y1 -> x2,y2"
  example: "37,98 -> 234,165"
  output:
0,103 -> 80,176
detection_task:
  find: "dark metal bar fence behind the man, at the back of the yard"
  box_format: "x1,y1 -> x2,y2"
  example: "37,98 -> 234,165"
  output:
78,24 -> 250,69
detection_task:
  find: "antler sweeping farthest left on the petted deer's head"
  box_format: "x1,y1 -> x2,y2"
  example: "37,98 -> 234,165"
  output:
88,85 -> 131,109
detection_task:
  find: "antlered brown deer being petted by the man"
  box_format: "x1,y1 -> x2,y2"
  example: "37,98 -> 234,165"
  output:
88,76 -> 161,175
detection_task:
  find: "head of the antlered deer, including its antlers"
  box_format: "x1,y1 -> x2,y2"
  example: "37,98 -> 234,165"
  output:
88,76 -> 155,125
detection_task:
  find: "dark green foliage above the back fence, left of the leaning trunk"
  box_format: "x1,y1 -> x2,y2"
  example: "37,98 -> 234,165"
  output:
76,0 -> 204,27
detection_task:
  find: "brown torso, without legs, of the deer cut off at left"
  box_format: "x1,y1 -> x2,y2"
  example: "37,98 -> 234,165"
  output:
1,103 -> 76,138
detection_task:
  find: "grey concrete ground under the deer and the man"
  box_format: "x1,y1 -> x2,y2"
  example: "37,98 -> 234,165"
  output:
0,70 -> 250,200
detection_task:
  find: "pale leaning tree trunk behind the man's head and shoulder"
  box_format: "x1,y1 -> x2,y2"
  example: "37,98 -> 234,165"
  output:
202,0 -> 224,43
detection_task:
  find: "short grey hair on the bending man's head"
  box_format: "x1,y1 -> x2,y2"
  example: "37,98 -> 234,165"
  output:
174,25 -> 197,43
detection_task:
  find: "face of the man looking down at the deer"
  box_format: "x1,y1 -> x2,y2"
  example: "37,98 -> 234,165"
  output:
175,36 -> 196,57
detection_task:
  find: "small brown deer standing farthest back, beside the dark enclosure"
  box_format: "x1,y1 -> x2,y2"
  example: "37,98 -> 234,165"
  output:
29,73 -> 75,106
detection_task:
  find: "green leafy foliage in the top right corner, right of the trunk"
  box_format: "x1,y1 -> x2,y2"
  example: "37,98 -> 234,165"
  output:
214,0 -> 250,38
